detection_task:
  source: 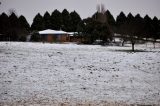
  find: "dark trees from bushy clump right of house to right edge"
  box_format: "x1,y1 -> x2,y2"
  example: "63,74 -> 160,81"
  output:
76,10 -> 160,46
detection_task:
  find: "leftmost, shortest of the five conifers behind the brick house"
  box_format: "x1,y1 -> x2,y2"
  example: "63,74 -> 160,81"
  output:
31,13 -> 45,31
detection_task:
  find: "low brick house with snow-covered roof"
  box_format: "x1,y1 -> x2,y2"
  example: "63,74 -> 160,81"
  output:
39,29 -> 70,42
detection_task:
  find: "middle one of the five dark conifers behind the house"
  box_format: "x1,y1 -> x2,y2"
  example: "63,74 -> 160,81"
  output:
51,10 -> 62,30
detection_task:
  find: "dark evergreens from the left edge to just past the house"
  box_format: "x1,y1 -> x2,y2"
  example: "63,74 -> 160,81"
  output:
0,9 -> 82,41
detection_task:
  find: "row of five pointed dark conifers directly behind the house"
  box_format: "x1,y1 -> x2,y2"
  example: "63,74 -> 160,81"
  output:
31,9 -> 82,32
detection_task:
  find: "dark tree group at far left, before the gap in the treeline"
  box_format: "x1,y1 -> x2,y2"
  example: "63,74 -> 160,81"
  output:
0,12 -> 30,41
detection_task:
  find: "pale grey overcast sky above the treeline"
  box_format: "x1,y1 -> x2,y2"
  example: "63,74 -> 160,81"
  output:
0,0 -> 160,24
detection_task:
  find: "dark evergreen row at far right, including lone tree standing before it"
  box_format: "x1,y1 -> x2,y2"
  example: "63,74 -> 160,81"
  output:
115,12 -> 160,51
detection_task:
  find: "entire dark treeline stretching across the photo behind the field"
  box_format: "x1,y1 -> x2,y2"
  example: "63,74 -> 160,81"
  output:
0,9 -> 160,45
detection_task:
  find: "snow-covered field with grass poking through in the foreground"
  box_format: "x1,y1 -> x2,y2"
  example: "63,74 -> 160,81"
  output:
0,42 -> 160,106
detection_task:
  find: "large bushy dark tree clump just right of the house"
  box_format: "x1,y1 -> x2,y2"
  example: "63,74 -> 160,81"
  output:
85,11 -> 112,43
